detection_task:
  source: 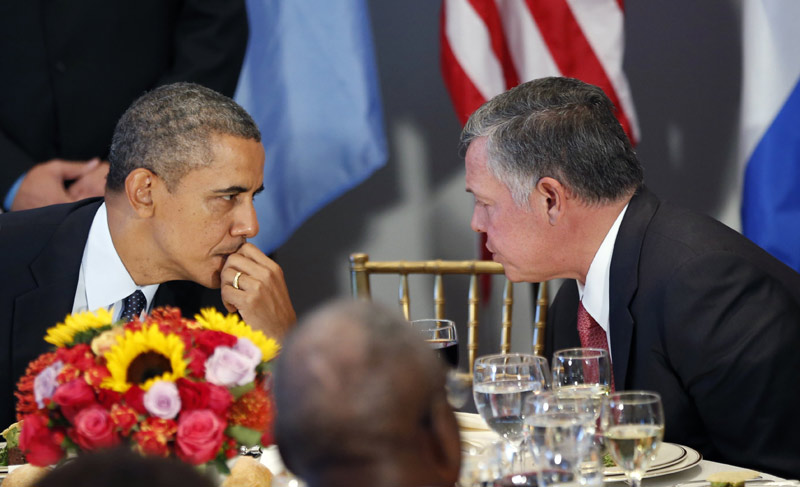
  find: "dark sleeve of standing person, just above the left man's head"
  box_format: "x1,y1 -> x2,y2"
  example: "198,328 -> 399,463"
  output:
158,0 -> 248,96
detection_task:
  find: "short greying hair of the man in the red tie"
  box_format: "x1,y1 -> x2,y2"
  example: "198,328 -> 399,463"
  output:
461,77 -> 644,207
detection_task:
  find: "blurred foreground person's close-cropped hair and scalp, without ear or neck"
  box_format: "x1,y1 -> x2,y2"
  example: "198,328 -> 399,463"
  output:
274,300 -> 447,480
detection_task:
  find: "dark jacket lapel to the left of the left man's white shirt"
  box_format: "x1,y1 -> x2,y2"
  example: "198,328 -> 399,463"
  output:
12,201 -> 101,374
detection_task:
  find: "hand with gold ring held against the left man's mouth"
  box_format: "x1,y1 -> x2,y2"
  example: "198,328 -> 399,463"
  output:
220,243 -> 297,341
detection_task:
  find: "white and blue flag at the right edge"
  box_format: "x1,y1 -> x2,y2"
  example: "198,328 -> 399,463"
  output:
741,0 -> 800,271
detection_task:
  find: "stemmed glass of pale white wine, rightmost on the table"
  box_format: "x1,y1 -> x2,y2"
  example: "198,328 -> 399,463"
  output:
600,391 -> 664,487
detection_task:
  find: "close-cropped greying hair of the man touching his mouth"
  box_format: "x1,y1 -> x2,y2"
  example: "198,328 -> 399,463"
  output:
106,83 -> 261,191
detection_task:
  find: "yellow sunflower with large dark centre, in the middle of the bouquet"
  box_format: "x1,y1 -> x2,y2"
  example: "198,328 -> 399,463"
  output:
101,325 -> 186,393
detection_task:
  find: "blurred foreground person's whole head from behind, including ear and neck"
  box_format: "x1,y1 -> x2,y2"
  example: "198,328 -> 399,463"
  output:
275,302 -> 460,487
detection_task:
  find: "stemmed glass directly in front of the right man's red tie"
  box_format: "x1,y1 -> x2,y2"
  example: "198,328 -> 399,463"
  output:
553,348 -> 611,418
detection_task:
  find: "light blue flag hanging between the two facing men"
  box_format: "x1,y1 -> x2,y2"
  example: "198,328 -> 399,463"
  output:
235,0 -> 387,253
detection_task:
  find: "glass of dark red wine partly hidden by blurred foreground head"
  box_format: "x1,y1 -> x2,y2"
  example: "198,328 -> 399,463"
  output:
411,318 -> 472,409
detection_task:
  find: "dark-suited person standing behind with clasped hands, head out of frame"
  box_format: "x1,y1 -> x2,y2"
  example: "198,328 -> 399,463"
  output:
0,0 -> 248,211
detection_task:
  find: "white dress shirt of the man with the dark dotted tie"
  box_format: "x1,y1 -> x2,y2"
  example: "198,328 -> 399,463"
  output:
72,203 -> 158,321
